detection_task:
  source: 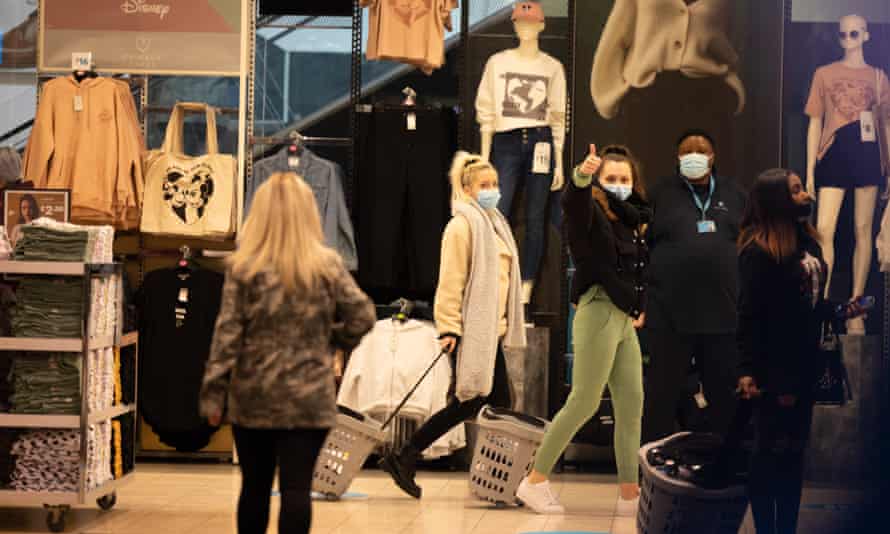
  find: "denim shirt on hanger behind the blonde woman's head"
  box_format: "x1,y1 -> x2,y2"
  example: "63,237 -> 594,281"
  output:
244,147 -> 358,272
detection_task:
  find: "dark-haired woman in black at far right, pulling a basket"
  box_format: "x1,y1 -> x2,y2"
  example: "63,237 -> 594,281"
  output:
738,169 -> 862,534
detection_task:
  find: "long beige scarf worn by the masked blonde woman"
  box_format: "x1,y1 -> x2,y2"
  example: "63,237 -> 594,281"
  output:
440,202 -> 526,401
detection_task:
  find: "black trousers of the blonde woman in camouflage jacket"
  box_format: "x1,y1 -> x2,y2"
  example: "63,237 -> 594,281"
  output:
232,426 -> 328,534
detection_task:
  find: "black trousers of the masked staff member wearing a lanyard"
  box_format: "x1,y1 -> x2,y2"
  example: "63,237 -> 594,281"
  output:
643,328 -> 738,443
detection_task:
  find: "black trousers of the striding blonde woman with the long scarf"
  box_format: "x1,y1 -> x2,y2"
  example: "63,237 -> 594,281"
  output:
407,347 -> 513,453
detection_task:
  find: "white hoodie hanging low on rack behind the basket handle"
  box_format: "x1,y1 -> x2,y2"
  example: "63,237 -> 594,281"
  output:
337,319 -> 466,458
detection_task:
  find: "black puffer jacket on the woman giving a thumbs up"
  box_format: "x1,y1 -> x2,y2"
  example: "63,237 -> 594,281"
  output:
562,169 -> 650,318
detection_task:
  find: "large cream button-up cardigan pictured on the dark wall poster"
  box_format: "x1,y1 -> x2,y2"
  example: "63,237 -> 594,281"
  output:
590,0 -> 745,119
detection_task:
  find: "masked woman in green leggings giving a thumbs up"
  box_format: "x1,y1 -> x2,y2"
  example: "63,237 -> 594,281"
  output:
516,145 -> 649,514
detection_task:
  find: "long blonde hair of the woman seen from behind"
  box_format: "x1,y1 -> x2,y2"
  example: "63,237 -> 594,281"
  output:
229,172 -> 341,293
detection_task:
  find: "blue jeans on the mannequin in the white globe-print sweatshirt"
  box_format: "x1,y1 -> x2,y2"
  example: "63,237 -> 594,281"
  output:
491,126 -> 554,282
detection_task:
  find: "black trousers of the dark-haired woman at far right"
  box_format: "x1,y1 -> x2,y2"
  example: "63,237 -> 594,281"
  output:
748,395 -> 813,534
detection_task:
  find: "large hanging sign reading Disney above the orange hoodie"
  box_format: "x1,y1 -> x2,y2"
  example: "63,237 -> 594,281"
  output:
38,0 -> 243,76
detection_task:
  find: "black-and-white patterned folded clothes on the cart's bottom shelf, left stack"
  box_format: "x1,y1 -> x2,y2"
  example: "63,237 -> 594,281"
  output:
10,430 -> 80,492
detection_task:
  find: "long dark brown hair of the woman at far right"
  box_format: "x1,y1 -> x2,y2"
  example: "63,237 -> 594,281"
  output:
738,169 -> 819,262
